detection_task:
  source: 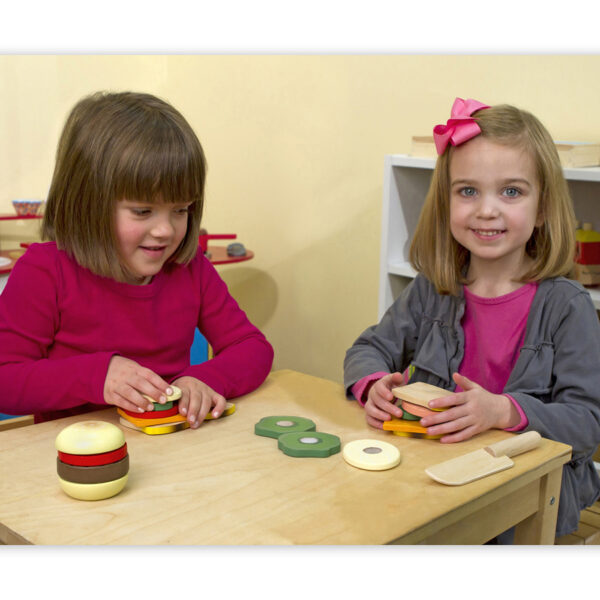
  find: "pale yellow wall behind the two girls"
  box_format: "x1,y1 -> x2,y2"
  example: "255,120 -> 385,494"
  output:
0,55 -> 600,381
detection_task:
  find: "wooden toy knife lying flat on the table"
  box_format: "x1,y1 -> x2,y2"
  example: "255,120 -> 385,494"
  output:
425,431 -> 542,485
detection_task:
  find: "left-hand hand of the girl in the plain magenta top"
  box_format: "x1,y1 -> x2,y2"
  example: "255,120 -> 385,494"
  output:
104,356 -> 172,412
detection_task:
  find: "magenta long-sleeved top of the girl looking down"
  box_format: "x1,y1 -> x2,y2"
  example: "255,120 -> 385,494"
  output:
0,242 -> 273,422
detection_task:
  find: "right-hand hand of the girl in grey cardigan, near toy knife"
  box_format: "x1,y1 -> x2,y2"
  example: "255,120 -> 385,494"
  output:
420,373 -> 520,443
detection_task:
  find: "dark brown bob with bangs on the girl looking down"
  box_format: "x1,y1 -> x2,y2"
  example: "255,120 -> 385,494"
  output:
42,92 -> 206,282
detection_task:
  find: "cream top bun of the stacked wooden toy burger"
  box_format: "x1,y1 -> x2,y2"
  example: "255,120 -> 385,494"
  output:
55,421 -> 125,454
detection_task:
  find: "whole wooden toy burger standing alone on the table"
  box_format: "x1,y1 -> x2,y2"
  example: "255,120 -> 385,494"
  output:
55,421 -> 129,500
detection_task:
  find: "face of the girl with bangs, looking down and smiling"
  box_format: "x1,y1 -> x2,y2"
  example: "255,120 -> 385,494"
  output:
115,200 -> 190,285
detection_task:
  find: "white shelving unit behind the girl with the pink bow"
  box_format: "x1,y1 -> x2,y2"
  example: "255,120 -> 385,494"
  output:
379,154 -> 600,319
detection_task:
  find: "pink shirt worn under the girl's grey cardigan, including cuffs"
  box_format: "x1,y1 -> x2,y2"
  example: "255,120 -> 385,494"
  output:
352,283 -> 537,431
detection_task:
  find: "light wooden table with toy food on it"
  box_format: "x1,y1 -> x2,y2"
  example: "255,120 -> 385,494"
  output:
0,370 -> 570,545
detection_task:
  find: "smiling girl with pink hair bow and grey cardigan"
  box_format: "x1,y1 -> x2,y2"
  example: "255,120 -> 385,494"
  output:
344,98 -> 600,535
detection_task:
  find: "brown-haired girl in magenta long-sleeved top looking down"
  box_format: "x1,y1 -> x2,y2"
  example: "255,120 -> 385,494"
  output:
0,92 -> 273,428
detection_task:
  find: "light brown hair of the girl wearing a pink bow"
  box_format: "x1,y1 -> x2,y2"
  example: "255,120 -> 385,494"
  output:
410,104 -> 575,295
